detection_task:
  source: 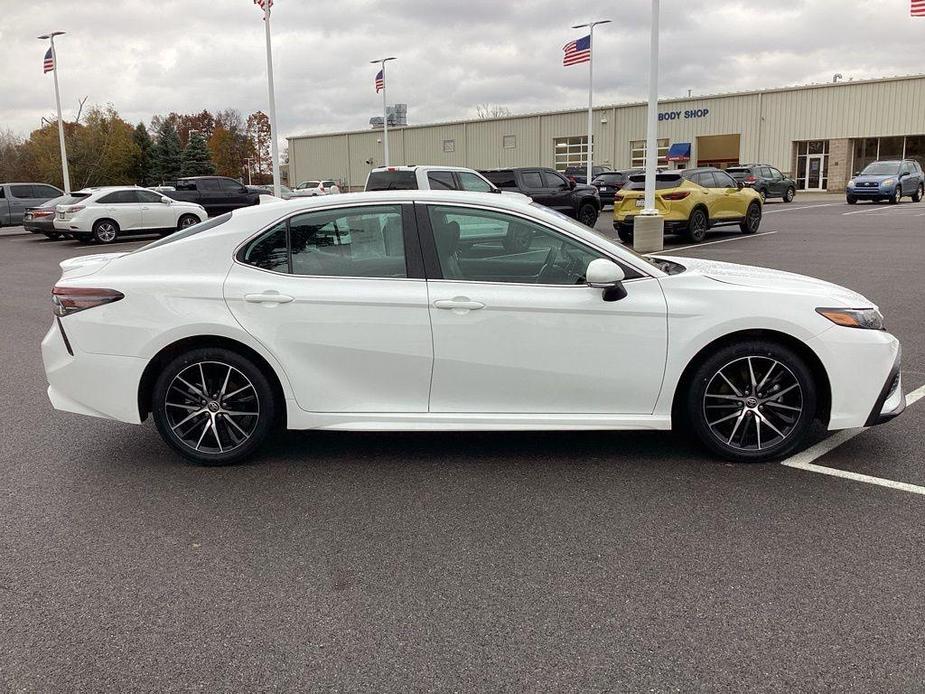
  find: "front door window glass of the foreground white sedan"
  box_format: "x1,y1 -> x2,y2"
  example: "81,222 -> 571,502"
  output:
427,205 -> 604,285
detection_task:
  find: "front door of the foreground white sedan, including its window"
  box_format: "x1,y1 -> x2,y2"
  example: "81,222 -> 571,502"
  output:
421,205 -> 667,414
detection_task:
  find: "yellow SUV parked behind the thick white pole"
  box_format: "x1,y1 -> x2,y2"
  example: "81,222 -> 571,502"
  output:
613,167 -> 762,243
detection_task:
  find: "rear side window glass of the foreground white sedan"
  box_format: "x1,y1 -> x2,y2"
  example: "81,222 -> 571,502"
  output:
240,205 -> 408,278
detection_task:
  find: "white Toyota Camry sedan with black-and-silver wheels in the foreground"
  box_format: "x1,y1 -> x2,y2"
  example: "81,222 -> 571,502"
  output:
42,191 -> 905,464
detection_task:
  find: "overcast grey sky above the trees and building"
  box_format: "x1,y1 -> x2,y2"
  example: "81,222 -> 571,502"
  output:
0,0 -> 925,143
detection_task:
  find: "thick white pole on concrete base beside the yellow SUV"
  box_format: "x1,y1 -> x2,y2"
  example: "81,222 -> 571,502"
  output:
633,0 -> 665,253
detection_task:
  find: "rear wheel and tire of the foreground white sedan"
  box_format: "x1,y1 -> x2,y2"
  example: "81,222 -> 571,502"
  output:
151,347 -> 278,465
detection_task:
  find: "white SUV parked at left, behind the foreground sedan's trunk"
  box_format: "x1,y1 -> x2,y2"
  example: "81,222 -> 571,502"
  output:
55,186 -> 208,243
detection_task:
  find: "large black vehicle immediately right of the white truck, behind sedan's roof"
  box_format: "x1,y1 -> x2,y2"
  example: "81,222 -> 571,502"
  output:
479,167 -> 601,227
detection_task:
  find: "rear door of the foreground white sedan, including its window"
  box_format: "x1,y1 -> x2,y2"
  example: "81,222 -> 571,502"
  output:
224,203 -> 433,413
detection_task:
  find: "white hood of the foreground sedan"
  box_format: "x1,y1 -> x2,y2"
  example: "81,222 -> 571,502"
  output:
657,255 -> 876,308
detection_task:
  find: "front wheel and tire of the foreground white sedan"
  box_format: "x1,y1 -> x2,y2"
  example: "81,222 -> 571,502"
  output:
685,340 -> 817,463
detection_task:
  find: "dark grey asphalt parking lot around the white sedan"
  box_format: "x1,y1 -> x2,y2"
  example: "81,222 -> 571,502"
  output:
0,197 -> 925,692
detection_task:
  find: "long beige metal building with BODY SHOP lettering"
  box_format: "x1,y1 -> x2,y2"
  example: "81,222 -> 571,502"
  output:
289,75 -> 925,190
